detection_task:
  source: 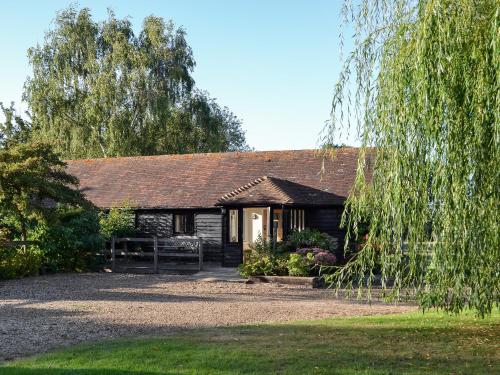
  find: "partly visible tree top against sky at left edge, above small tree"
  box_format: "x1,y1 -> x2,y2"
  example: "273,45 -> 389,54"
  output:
0,102 -> 31,149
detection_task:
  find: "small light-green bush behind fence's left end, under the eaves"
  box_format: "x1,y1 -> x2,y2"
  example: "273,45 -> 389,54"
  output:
99,205 -> 135,240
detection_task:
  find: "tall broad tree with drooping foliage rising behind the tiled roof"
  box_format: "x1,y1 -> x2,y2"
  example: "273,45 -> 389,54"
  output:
24,7 -> 245,158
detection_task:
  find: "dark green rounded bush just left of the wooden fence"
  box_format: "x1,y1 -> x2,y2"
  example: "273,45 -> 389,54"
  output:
32,207 -> 104,272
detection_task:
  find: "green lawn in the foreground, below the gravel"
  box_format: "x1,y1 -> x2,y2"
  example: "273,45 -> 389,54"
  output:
0,311 -> 500,375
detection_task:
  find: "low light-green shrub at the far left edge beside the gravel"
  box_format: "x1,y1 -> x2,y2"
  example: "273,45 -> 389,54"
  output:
0,244 -> 42,280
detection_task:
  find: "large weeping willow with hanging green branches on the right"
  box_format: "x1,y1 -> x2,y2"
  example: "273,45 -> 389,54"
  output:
326,0 -> 500,315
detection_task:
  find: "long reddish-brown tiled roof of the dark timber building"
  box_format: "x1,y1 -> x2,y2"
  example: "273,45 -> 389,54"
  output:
67,148 -> 370,208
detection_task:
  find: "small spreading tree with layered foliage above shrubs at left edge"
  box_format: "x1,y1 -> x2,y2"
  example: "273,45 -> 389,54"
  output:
0,143 -> 91,241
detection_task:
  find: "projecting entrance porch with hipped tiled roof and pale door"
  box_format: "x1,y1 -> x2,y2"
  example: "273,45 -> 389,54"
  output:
219,176 -> 343,266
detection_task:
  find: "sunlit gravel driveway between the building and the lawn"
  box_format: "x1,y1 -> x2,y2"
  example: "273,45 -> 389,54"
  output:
0,273 -> 414,360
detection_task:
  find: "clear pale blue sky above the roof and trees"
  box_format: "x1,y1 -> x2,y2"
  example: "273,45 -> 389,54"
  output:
0,0 -> 357,150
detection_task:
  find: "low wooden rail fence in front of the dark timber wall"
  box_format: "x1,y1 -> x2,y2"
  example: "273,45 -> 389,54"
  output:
111,236 -> 203,273
